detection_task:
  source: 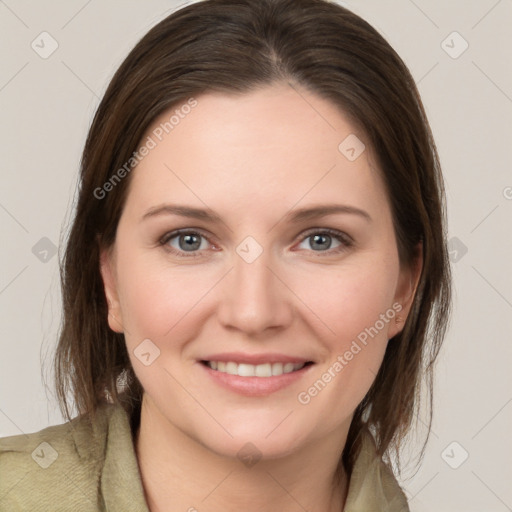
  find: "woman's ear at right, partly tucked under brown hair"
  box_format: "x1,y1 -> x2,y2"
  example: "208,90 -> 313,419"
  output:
388,242 -> 423,339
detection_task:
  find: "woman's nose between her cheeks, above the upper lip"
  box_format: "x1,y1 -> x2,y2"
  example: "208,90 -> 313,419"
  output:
217,247 -> 294,336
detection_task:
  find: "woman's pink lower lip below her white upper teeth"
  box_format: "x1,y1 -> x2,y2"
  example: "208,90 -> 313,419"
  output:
198,363 -> 314,396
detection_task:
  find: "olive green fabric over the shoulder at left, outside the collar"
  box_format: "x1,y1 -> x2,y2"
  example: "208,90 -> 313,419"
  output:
0,404 -> 120,512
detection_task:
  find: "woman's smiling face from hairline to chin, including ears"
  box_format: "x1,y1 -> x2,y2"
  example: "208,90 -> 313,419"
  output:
101,85 -> 419,457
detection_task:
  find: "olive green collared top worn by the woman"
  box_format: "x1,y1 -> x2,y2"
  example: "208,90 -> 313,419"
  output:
0,404 -> 409,512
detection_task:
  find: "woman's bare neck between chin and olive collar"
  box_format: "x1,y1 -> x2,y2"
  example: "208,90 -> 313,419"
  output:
135,394 -> 348,512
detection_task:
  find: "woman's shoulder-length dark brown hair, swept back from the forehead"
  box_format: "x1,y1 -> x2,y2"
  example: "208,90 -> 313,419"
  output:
55,0 -> 451,480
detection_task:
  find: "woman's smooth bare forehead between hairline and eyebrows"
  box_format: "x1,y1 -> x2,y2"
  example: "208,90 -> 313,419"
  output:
124,85 -> 385,221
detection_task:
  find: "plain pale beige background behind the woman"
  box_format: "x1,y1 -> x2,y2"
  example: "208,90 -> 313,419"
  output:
0,0 -> 512,512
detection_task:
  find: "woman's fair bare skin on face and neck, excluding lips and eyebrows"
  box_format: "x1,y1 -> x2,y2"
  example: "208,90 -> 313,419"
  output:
101,84 -> 421,512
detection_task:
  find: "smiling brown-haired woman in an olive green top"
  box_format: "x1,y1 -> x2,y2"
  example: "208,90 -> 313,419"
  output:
0,0 -> 450,512
